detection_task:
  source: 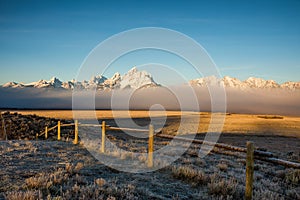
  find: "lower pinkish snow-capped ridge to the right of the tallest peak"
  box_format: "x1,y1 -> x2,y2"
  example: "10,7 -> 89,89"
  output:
189,76 -> 300,90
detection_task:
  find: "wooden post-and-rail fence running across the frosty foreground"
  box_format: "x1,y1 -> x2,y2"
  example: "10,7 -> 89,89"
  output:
1,118 -> 300,200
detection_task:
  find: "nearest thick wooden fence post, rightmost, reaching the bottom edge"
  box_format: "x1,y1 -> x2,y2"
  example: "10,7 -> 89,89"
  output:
245,141 -> 254,200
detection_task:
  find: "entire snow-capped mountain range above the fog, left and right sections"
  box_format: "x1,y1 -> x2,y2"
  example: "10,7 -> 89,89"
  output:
2,67 -> 300,90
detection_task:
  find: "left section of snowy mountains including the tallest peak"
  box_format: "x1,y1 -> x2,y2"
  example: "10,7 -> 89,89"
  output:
2,67 -> 159,90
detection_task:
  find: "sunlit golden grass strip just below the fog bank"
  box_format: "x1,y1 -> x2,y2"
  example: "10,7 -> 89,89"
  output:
9,110 -> 300,137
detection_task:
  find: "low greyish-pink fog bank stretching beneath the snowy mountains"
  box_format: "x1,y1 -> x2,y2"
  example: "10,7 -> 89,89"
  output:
0,86 -> 300,115
